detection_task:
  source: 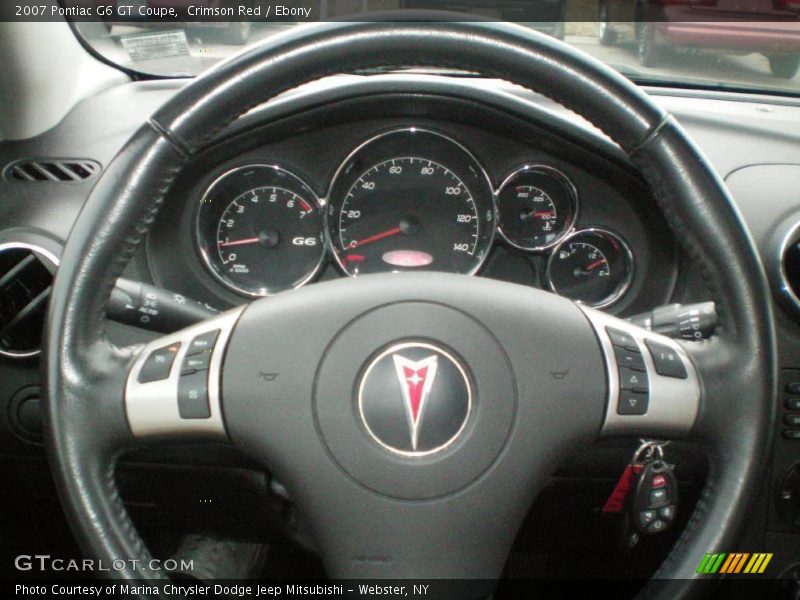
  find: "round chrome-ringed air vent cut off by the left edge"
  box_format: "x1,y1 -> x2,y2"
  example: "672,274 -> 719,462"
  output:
0,243 -> 58,358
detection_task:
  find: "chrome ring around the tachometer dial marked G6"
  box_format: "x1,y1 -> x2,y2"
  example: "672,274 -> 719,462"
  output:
194,162 -> 328,298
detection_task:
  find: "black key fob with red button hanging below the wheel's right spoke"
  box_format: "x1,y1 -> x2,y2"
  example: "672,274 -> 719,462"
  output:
629,459 -> 678,534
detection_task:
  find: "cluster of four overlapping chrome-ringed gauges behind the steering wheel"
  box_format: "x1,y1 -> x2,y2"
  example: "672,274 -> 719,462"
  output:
195,127 -> 634,307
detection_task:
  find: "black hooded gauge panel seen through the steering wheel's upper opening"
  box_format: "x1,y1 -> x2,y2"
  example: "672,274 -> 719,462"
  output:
145,86 -> 679,312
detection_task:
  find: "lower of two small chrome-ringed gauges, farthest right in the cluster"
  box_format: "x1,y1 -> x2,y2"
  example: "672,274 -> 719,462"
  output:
547,229 -> 633,308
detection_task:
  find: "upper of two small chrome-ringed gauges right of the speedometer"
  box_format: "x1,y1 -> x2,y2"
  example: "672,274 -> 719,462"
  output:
497,165 -> 578,251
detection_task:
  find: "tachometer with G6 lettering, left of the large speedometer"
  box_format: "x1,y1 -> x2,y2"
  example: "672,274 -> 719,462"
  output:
197,165 -> 324,296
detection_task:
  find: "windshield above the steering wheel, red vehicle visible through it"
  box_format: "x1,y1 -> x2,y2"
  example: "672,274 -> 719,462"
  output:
67,0 -> 800,95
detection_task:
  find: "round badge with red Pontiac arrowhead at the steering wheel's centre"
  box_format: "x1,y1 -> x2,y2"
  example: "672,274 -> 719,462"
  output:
358,342 -> 472,456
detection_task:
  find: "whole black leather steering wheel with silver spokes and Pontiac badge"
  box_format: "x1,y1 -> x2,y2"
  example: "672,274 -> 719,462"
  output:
46,22 -> 776,598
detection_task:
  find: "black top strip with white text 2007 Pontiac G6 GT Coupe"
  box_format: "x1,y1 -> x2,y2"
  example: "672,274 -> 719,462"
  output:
0,0 -> 800,22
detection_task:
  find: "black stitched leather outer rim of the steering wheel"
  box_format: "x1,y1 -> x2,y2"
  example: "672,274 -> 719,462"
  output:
46,23 -> 776,597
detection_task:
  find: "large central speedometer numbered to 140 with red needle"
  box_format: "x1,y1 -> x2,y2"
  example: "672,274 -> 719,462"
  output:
326,129 -> 495,276
